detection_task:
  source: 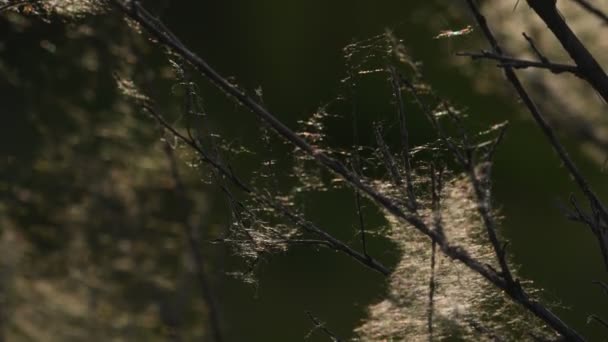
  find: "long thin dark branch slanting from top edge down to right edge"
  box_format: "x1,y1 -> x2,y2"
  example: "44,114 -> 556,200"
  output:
466,0 -> 608,269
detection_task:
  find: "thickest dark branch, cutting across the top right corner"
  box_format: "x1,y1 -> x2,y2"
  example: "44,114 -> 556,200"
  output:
527,0 -> 608,103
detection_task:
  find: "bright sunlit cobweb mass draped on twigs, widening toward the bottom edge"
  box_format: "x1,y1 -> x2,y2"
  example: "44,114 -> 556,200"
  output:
338,33 -> 547,341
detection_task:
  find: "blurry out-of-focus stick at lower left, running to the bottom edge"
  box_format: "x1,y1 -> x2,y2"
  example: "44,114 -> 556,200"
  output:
165,142 -> 224,342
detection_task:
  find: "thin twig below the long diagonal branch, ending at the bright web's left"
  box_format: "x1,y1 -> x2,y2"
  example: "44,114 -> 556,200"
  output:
143,104 -> 390,276
